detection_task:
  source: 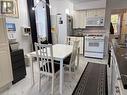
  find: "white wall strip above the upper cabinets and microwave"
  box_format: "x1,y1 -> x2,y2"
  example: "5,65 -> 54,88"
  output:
74,0 -> 106,10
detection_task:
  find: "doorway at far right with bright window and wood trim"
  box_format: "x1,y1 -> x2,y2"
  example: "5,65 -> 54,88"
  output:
111,9 -> 127,42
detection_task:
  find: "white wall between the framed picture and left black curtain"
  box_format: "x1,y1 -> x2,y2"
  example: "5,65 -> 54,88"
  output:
6,0 -> 31,54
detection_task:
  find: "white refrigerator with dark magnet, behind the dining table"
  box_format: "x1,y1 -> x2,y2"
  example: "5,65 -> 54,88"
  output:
51,14 -> 73,44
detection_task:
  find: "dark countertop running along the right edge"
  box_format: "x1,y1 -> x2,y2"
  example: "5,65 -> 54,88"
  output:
113,39 -> 127,89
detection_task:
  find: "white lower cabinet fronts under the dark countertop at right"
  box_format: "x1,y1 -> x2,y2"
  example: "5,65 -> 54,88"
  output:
110,49 -> 124,95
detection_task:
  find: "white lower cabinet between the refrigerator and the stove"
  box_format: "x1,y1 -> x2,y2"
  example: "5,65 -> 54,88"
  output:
67,36 -> 83,54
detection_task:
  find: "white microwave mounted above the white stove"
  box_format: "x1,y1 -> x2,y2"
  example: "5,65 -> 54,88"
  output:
86,17 -> 104,26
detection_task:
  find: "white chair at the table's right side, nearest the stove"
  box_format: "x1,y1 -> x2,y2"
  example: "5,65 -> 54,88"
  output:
64,41 -> 79,73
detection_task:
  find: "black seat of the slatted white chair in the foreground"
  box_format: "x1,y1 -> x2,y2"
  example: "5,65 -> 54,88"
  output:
40,63 -> 60,73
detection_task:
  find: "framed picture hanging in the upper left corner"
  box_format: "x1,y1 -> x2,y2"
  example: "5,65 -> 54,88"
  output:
0,0 -> 19,17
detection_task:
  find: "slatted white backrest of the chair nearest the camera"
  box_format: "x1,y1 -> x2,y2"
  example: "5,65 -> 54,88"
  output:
35,43 -> 54,74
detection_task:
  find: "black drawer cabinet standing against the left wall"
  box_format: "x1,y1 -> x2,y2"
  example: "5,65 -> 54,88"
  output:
11,49 -> 26,84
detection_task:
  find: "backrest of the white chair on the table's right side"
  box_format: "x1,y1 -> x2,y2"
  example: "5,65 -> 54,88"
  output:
70,41 -> 79,65
